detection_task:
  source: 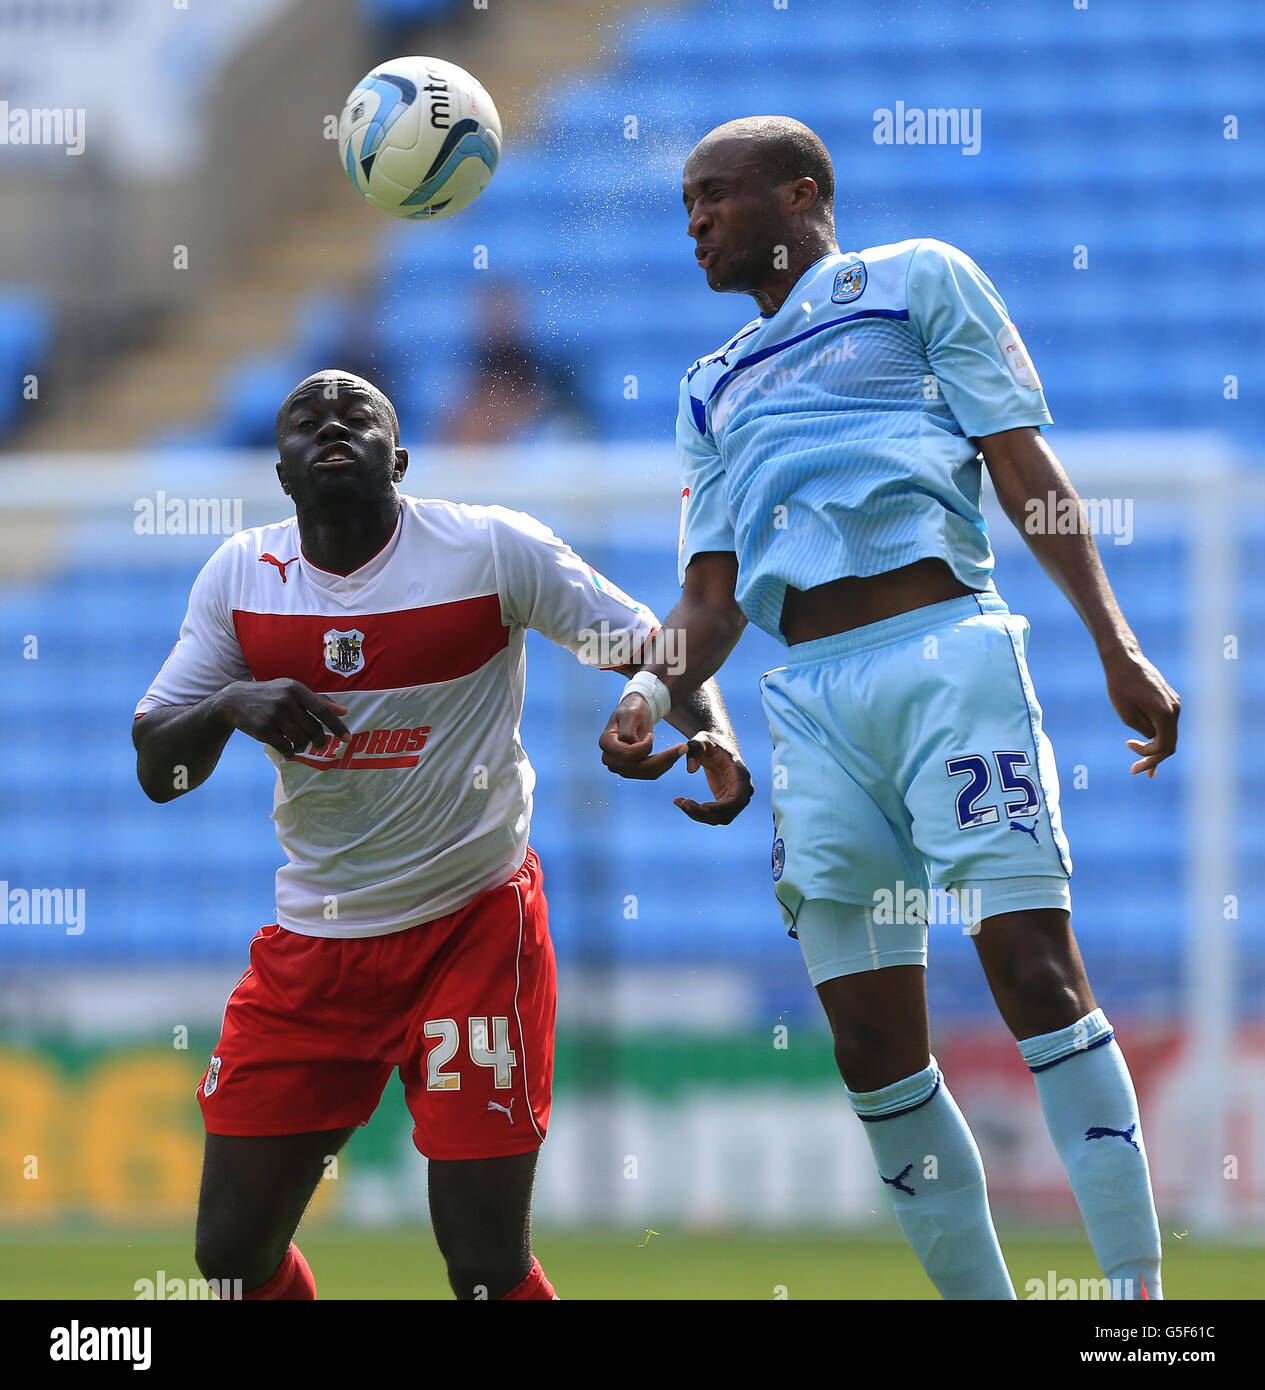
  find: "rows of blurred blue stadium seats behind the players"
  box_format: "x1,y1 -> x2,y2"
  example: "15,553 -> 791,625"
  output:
0,0 -> 1265,1016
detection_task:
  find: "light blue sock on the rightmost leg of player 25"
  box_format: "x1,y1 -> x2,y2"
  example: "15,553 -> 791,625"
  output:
1019,1009 -> 1164,1298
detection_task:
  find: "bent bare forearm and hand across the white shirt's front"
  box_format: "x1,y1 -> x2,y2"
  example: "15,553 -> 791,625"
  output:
132,680 -> 350,802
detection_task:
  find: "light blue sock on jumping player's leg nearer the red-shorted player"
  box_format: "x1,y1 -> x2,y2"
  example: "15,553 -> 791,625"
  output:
848,1056 -> 1015,1298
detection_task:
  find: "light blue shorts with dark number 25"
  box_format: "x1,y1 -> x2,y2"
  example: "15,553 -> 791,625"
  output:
760,591 -> 1072,984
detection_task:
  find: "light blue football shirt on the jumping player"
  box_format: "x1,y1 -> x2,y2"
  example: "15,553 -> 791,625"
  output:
677,238 -> 1052,642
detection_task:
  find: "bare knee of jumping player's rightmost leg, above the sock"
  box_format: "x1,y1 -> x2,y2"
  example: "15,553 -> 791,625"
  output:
974,908 -> 1095,1041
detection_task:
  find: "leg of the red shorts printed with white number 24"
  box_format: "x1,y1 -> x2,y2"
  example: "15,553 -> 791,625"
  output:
400,852 -> 557,1161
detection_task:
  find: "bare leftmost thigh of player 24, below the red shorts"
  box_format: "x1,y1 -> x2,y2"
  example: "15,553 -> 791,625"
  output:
196,1127 -> 353,1287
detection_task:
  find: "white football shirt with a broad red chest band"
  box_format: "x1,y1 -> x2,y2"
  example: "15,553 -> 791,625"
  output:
136,496 -> 659,937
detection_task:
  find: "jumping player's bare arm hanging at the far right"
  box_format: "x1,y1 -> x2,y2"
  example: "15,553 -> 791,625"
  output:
979,417 -> 1182,777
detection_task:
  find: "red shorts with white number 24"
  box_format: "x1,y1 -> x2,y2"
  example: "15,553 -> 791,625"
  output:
197,849 -> 556,1159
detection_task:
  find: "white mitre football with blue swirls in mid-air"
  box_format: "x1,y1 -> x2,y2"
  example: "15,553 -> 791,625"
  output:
338,58 -> 500,218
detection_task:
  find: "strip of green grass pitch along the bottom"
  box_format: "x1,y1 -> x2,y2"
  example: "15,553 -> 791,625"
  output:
0,1227 -> 1265,1300
